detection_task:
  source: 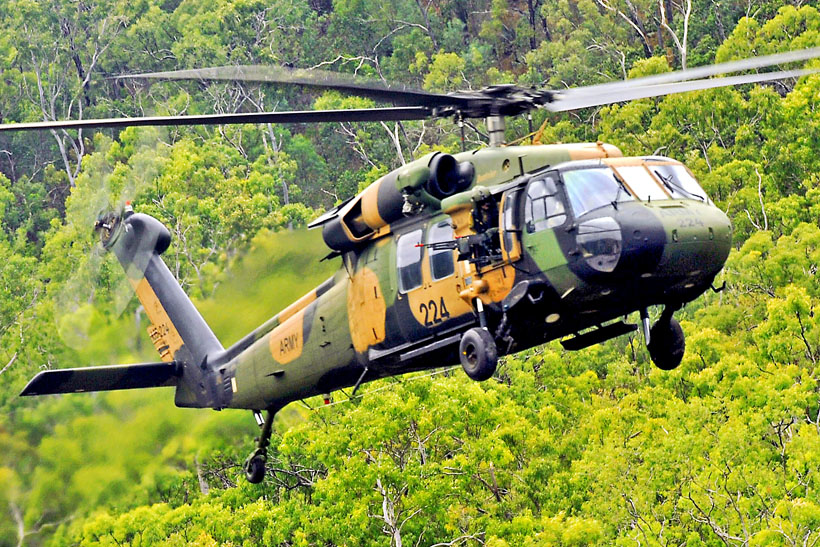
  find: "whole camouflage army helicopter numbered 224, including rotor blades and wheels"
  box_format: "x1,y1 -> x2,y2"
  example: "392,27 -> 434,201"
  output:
0,48 -> 820,483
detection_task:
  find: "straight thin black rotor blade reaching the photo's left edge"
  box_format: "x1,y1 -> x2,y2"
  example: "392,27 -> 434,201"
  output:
0,106 -> 433,132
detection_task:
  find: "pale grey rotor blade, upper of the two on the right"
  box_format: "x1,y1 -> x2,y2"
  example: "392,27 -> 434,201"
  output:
562,47 -> 820,96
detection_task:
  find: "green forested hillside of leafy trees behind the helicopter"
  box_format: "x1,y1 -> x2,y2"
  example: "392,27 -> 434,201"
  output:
0,0 -> 820,547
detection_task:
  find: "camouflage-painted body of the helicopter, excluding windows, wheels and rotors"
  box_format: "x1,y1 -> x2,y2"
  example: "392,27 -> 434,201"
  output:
23,143 -> 731,418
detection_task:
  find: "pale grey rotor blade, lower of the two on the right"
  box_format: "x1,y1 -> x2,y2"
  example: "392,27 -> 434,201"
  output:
544,69 -> 820,112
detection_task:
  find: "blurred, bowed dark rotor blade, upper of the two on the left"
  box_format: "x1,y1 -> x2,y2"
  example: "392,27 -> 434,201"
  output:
117,65 -> 462,107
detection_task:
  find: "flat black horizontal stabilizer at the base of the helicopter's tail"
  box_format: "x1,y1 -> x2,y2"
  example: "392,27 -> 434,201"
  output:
20,361 -> 182,396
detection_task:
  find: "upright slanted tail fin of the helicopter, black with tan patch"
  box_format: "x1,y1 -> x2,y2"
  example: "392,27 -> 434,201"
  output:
103,213 -> 224,407
